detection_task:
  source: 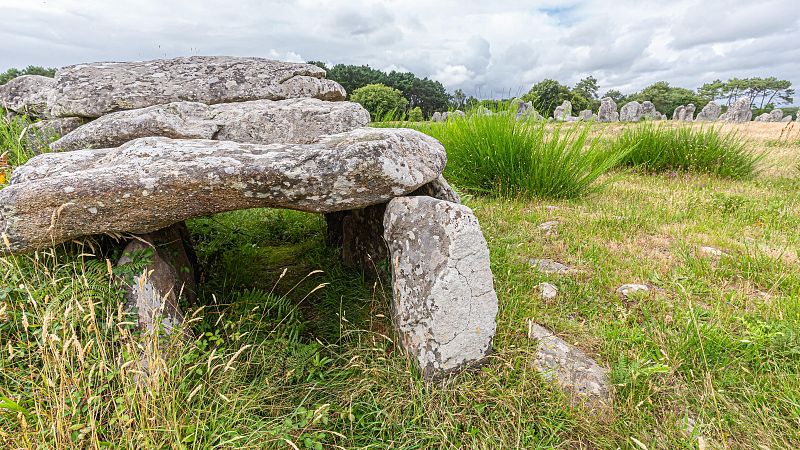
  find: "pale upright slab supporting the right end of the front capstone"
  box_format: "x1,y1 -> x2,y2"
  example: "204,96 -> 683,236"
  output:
384,197 -> 497,379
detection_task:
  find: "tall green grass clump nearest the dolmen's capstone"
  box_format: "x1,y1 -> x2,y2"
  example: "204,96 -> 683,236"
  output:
420,113 -> 627,198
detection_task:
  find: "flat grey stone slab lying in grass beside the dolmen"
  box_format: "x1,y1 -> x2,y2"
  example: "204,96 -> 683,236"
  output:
528,321 -> 612,411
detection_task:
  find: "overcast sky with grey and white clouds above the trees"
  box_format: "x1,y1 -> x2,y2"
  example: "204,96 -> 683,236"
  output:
0,0 -> 800,97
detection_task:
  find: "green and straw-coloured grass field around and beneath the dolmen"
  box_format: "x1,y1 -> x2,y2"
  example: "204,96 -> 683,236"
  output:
0,118 -> 800,449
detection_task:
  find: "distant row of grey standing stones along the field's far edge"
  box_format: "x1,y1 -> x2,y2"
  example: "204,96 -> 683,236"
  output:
431,97 -> 800,123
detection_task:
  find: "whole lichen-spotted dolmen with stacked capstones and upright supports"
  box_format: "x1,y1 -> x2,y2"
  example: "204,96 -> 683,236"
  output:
0,56 -> 498,380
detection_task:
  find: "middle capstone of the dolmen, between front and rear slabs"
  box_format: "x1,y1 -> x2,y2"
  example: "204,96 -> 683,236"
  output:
50,98 -> 369,151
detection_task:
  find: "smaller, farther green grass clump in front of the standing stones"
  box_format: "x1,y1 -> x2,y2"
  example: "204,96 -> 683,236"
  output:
610,123 -> 764,179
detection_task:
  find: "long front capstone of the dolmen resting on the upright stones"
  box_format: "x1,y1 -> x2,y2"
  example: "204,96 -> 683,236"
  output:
0,128 -> 446,253
